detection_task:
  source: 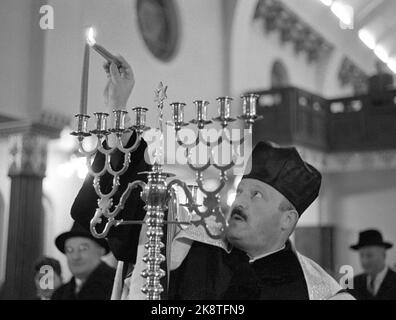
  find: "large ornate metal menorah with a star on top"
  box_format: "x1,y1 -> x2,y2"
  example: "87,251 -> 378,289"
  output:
71,83 -> 260,300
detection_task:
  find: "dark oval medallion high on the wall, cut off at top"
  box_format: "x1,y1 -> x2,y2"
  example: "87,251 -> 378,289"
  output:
136,0 -> 179,61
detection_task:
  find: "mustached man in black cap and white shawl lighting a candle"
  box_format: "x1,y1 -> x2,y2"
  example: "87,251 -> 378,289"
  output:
71,53 -> 353,300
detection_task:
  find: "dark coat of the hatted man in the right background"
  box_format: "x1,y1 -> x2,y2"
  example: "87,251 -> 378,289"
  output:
349,269 -> 396,300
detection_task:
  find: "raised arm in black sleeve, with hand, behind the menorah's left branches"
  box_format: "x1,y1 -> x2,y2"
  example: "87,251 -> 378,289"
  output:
71,56 -> 151,263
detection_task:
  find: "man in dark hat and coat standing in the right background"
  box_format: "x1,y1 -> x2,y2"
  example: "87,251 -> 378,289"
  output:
350,229 -> 396,300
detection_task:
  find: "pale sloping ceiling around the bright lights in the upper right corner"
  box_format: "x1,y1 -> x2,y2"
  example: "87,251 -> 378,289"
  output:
281,0 -> 396,71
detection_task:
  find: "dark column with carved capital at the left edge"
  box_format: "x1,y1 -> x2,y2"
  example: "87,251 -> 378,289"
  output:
2,130 -> 49,299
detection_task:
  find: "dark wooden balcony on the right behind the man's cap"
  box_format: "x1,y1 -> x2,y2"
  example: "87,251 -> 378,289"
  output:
253,87 -> 396,152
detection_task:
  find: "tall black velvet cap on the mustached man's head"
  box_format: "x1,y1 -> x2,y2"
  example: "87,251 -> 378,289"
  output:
242,141 -> 322,216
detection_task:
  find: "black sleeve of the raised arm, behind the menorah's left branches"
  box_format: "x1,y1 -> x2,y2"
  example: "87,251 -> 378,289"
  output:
71,133 -> 151,263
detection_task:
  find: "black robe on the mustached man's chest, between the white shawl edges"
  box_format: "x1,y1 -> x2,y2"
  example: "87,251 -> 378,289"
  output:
169,241 -> 309,300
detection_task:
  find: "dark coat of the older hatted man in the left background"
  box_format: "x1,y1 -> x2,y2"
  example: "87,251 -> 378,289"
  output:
51,262 -> 115,300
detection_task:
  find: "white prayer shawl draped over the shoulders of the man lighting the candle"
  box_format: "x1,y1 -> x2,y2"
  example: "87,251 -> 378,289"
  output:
112,222 -> 354,300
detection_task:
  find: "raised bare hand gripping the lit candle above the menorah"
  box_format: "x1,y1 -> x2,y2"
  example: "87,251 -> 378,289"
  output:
103,56 -> 135,109
